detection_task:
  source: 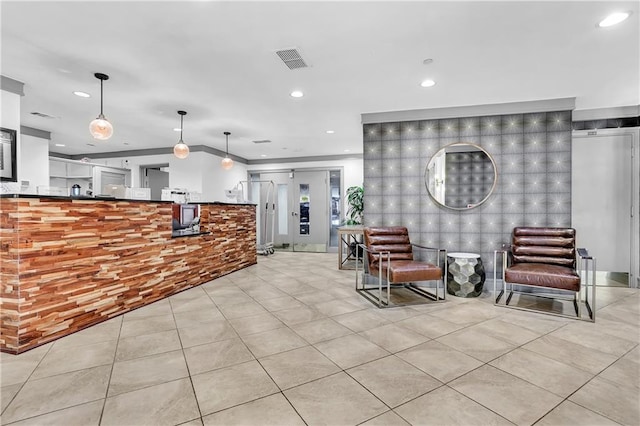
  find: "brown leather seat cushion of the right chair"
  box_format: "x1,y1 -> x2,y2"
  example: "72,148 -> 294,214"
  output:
504,263 -> 580,291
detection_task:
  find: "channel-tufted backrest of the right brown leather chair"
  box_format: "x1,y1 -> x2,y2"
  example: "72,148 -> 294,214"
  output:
511,227 -> 576,269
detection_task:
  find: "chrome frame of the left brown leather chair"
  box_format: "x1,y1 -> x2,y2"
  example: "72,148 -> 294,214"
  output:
356,243 -> 447,308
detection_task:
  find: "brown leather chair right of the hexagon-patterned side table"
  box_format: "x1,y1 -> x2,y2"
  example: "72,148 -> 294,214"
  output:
494,227 -> 595,321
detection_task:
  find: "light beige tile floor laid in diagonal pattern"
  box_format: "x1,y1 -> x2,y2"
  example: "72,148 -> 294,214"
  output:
0,253 -> 640,426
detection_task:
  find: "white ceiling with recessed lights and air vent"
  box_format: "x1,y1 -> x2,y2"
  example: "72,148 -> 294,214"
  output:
1,0 -> 640,159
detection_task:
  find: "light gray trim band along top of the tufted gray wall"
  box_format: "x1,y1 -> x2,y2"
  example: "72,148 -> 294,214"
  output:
361,98 -> 576,124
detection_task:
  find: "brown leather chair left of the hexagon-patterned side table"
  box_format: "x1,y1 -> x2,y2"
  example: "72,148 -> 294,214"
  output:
356,226 -> 447,308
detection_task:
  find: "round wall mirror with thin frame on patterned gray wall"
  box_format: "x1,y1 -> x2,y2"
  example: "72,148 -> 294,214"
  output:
425,142 -> 498,210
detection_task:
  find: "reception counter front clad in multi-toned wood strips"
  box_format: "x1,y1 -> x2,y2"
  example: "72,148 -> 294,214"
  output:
0,195 -> 257,353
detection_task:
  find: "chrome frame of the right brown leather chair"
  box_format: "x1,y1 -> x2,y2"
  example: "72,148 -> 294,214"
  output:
493,245 -> 596,322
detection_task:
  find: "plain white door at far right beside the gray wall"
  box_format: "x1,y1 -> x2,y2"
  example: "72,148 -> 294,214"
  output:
571,134 -> 633,282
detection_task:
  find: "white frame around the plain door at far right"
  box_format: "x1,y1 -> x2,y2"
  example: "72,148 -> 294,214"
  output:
572,127 -> 640,288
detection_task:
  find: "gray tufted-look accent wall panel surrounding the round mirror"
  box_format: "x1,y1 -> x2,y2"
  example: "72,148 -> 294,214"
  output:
363,111 -> 571,271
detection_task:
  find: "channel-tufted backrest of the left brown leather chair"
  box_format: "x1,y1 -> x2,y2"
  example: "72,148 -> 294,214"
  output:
364,226 -> 413,268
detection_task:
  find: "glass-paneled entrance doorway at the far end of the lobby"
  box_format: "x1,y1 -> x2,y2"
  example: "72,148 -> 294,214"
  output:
250,170 -> 340,253
